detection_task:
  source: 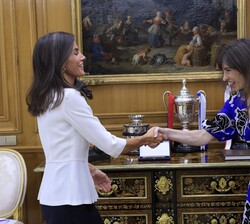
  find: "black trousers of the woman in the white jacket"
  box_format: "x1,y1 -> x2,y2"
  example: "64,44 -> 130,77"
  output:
42,204 -> 103,224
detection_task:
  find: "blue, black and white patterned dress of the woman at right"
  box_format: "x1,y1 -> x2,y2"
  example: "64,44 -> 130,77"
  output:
202,92 -> 250,224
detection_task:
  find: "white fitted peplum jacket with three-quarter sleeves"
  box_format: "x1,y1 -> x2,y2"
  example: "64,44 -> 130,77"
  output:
37,88 -> 126,206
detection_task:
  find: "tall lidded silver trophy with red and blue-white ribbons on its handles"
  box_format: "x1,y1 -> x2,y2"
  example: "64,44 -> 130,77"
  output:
163,79 -> 205,152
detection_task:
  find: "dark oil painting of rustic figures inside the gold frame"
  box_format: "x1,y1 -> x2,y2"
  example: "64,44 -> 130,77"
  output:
81,0 -> 237,75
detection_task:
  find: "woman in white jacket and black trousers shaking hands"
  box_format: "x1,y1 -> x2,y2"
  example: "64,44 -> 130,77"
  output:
26,32 -> 163,224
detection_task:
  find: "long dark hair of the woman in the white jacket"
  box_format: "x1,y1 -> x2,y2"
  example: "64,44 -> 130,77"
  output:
26,32 -> 75,116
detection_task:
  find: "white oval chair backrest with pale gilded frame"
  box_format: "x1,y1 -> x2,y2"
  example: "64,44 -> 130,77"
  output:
0,148 -> 27,221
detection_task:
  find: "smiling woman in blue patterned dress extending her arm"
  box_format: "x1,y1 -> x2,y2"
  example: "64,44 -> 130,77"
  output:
158,38 -> 250,223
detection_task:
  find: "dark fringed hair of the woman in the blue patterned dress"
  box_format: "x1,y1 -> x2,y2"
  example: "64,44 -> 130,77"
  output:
217,38 -> 250,98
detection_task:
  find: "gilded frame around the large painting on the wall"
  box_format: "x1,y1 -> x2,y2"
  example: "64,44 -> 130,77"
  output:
72,0 -> 246,85
